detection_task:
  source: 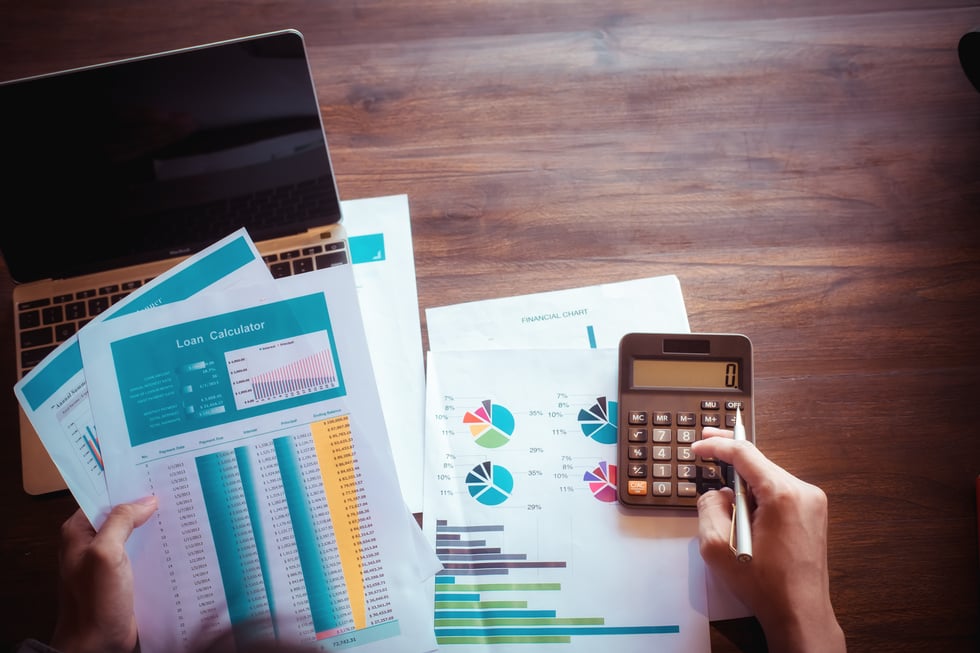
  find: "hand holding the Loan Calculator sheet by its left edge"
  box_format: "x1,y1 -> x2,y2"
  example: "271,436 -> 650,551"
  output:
51,496 -> 157,653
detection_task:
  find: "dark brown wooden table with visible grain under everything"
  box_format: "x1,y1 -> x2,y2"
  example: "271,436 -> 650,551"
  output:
0,0 -> 980,652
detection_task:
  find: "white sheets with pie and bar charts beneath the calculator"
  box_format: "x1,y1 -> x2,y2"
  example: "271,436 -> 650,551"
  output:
423,276 -> 737,653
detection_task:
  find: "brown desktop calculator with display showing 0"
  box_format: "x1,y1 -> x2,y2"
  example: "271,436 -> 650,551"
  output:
617,333 -> 755,509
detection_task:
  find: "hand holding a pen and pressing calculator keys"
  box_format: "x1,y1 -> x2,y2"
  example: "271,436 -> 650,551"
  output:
692,427 -> 846,653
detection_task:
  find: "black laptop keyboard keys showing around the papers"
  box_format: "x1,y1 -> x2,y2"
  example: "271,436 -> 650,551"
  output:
17,242 -> 349,374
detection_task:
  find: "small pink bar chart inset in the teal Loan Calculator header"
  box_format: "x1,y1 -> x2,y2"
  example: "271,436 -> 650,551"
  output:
225,331 -> 340,410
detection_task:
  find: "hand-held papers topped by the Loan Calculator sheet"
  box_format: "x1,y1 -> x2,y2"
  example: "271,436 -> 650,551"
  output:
15,196 -> 440,653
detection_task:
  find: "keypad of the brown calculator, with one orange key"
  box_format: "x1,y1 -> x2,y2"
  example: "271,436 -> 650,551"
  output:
619,398 -> 749,508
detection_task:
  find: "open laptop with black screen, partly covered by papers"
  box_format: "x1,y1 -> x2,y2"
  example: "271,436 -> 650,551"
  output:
0,30 -> 349,494
